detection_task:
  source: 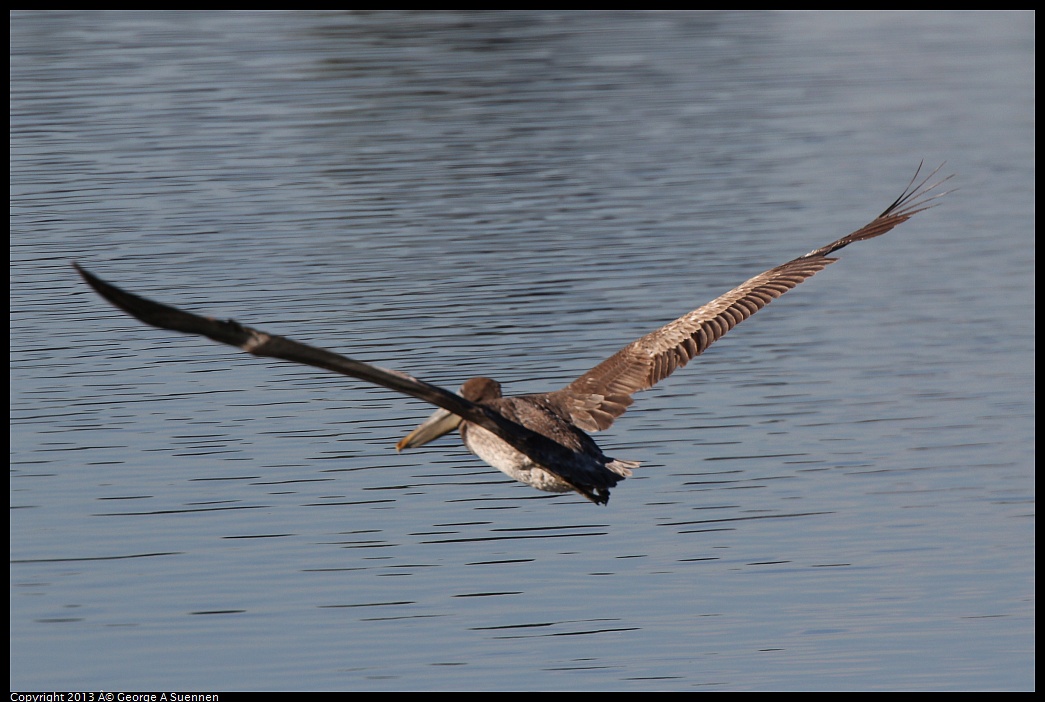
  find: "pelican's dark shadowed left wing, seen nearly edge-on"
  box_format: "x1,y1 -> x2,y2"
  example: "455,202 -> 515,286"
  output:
73,263 -> 623,501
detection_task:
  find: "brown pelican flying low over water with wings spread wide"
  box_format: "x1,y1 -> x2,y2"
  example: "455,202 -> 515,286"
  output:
73,166 -> 950,505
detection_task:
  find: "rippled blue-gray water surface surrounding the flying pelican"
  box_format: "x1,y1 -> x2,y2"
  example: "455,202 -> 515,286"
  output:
10,13 -> 1035,691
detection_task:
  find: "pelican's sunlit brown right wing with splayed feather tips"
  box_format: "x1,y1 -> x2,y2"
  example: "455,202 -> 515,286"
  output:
550,165 -> 951,431
